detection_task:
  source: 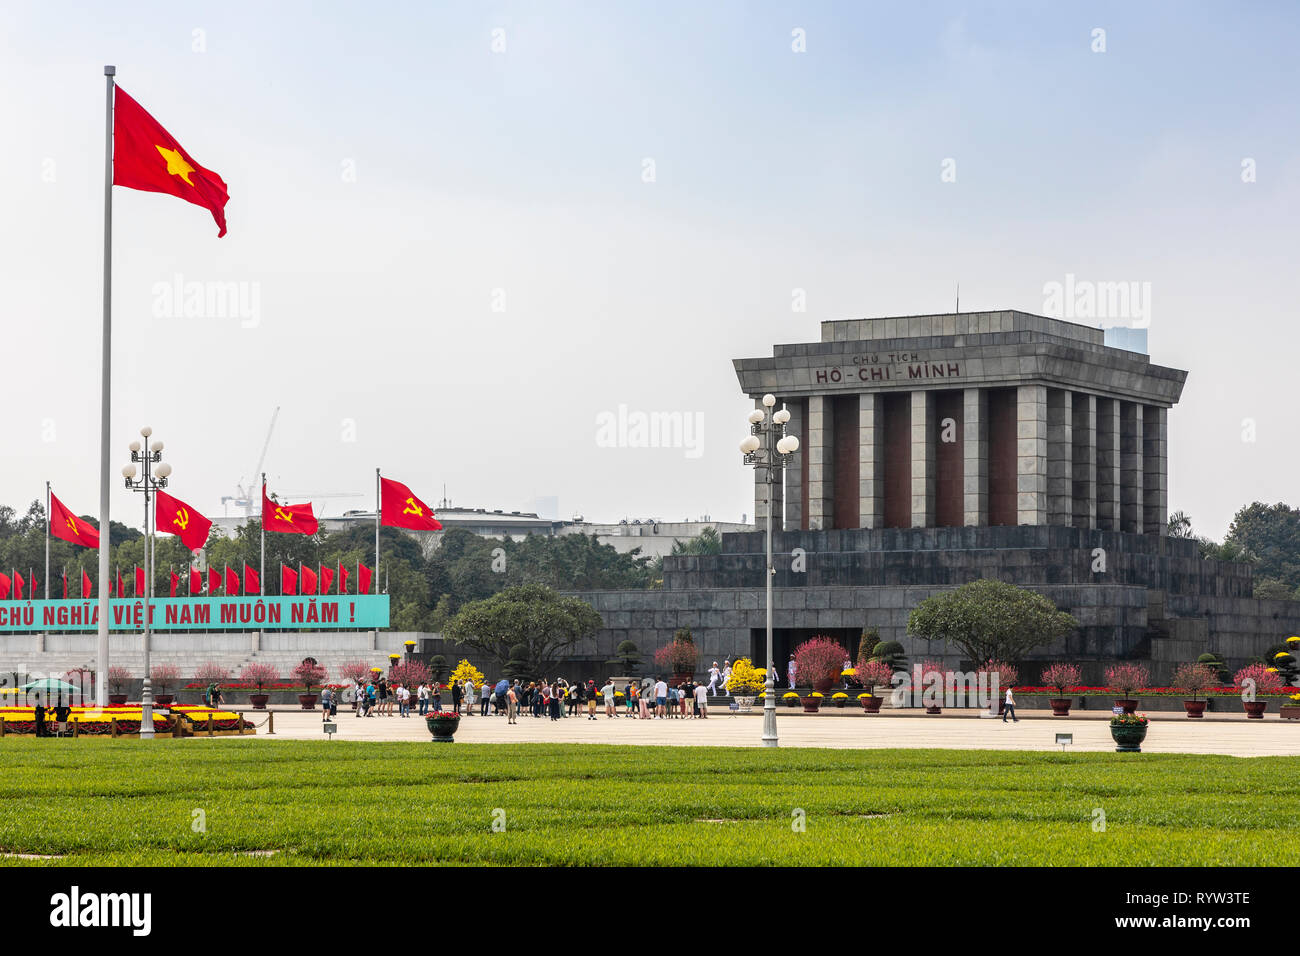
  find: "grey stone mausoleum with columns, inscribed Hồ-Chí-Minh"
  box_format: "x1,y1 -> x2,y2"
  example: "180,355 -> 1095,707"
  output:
575,311 -> 1300,683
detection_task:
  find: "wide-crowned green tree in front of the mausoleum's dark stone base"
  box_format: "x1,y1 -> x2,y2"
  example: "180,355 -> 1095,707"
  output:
907,579 -> 1079,661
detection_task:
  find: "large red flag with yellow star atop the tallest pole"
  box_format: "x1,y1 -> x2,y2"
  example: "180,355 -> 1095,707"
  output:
113,87 -> 230,239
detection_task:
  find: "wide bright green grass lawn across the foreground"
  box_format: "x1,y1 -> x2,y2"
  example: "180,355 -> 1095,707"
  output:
0,737 -> 1300,866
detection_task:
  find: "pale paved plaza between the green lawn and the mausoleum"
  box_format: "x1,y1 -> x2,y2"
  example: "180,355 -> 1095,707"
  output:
222,708 -> 1300,757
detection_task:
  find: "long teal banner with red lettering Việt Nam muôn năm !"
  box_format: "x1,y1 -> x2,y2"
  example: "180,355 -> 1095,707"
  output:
0,594 -> 389,633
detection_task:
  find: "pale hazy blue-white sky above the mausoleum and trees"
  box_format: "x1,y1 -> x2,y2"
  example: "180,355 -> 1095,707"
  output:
0,0 -> 1300,536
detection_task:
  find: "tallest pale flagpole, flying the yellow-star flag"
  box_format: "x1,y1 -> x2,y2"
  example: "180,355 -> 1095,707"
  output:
95,66 -> 117,708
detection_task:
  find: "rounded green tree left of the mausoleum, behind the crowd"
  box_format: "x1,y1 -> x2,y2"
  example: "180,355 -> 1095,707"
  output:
445,584 -> 603,674
